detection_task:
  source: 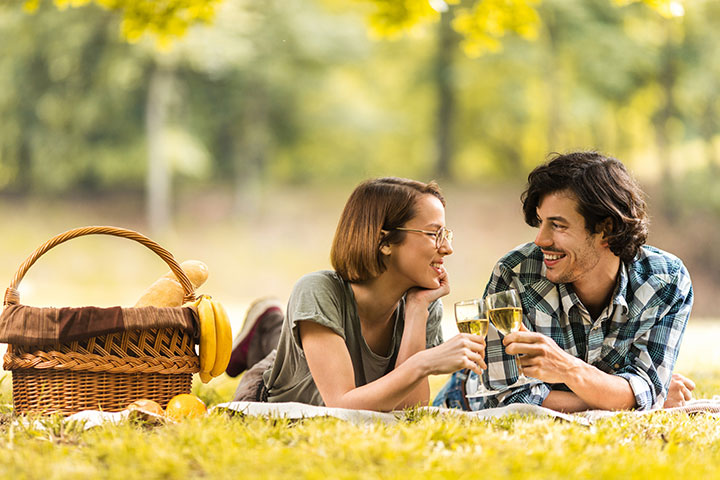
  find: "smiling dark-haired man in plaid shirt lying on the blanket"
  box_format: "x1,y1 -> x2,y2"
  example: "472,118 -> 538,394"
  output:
434,152 -> 694,412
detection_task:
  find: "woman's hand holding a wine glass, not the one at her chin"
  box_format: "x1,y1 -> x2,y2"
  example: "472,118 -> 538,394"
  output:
417,333 -> 487,375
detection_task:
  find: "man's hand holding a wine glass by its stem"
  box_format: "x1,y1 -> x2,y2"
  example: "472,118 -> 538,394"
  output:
503,325 -> 584,383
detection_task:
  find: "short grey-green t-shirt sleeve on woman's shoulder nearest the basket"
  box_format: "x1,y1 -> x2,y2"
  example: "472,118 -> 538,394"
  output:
287,272 -> 345,349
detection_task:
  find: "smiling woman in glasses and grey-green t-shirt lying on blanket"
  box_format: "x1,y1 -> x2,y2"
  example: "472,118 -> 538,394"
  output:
228,178 -> 485,411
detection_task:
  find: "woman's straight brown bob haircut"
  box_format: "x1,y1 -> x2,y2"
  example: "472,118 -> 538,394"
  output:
330,177 -> 445,282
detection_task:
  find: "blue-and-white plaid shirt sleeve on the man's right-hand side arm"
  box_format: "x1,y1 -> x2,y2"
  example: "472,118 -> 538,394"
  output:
615,266 -> 693,410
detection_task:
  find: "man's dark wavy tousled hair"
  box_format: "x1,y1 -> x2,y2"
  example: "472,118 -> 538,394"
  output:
521,152 -> 649,262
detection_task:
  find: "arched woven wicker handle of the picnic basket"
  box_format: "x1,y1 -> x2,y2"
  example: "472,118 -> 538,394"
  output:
3,226 -> 195,305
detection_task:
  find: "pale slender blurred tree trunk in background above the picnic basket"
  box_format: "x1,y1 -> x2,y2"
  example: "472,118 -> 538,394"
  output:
145,64 -> 173,234
